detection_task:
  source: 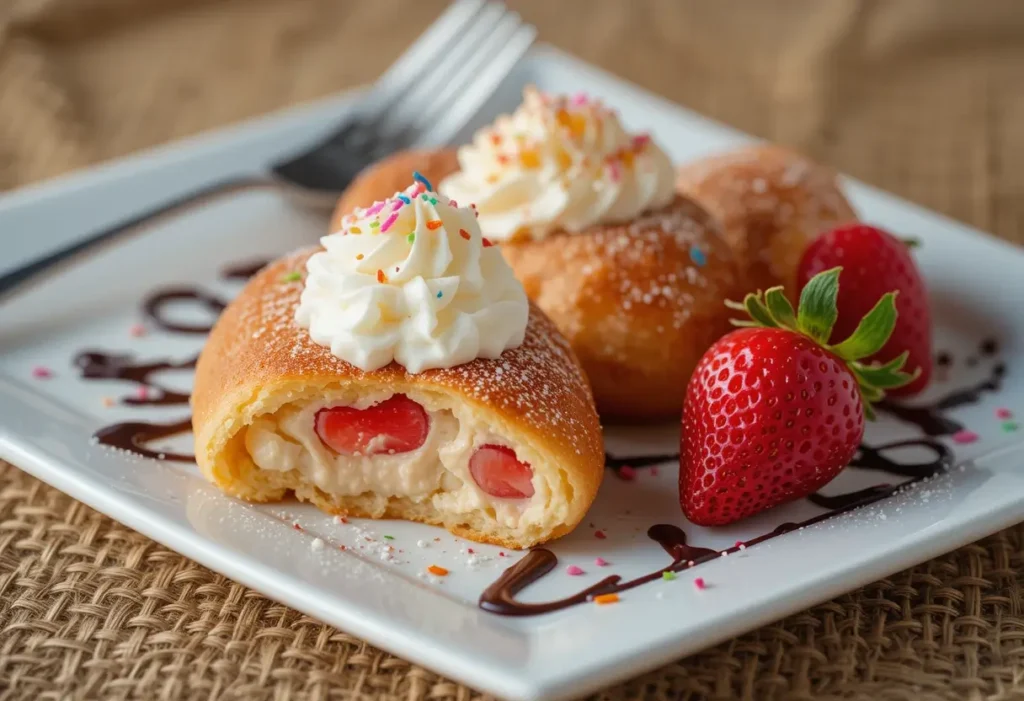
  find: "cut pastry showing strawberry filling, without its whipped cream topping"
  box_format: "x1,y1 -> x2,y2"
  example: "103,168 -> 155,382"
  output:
193,248 -> 604,549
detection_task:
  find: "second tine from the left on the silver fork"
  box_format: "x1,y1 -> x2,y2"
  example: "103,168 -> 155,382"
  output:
377,2 -> 506,141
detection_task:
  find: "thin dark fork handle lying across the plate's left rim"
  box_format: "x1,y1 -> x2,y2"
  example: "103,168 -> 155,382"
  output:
0,176 -> 278,299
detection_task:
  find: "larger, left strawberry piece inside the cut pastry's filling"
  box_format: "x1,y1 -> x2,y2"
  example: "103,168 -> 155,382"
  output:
315,394 -> 430,455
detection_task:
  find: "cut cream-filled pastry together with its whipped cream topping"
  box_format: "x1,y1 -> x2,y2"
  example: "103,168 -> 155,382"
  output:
193,187 -> 604,547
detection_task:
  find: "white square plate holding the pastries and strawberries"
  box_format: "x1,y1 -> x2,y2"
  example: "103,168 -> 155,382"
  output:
0,48 -> 1024,699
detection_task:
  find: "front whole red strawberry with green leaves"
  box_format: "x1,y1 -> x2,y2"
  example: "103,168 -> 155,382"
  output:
679,268 -> 912,526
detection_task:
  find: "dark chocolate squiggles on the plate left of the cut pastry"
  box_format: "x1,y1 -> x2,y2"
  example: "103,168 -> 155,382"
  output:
88,260 -> 267,463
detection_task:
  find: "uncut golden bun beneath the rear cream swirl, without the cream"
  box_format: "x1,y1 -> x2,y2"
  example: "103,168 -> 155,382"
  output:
502,196 -> 737,422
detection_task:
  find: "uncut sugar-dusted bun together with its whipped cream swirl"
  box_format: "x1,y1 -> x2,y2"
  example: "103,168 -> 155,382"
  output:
438,89 -> 737,421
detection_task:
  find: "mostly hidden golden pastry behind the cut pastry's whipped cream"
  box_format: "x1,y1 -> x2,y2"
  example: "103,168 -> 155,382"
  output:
331,148 -> 456,231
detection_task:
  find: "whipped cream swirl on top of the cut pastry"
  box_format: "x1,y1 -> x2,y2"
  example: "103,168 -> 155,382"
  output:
295,181 -> 529,374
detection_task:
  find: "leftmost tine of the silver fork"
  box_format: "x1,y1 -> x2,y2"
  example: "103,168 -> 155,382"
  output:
366,0 -> 486,121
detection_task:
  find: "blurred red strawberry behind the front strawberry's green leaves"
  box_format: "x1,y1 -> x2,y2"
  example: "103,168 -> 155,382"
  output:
798,224 -> 932,395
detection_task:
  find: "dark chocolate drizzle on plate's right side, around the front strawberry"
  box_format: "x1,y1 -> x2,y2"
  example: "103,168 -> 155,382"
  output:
479,341 -> 1006,616
